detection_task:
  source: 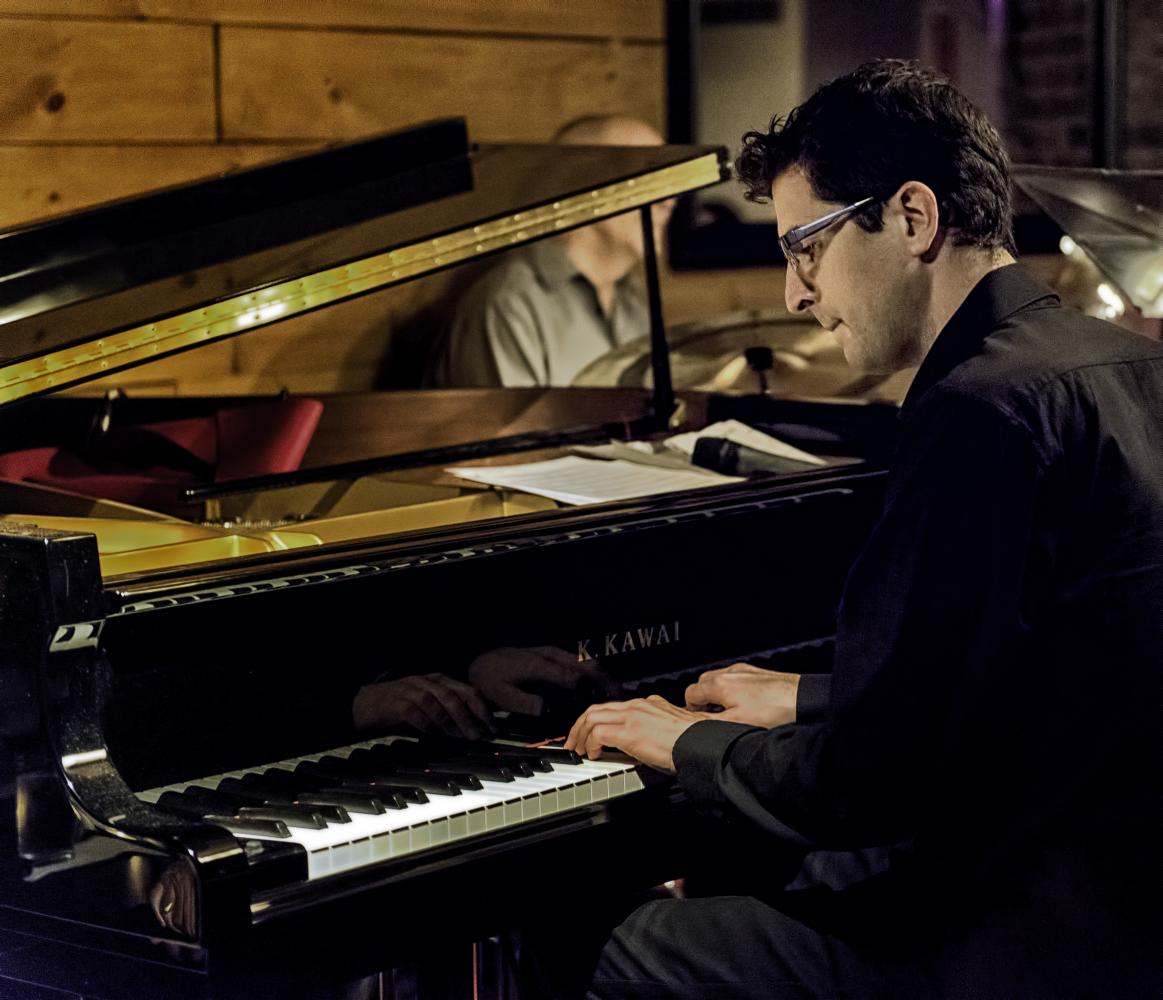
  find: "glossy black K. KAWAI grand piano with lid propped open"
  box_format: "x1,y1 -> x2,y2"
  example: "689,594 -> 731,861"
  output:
0,121 -> 894,1000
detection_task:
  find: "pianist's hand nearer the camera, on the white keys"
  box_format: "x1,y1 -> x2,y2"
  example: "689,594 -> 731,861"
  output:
565,694 -> 707,773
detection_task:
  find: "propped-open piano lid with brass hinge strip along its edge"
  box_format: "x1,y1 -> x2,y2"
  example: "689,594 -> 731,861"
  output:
0,119 -> 726,405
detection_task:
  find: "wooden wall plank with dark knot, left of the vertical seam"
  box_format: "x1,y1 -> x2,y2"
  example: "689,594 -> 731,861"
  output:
0,19 -> 216,142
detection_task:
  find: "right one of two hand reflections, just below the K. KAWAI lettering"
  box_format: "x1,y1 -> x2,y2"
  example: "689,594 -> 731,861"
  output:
469,645 -> 620,717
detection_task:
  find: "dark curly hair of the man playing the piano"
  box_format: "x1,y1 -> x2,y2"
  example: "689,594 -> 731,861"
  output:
735,59 -> 1014,252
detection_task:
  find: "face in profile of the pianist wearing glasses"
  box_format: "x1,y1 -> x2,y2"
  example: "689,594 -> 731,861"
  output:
771,167 -> 923,373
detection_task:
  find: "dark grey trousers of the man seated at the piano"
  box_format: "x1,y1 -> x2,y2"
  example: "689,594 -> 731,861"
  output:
586,895 -> 1163,1000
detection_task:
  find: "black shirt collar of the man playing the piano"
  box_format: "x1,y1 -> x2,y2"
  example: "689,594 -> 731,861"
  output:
900,264 -> 1058,416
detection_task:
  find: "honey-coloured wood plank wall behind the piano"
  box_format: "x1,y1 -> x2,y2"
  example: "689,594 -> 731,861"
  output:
0,0 -> 707,393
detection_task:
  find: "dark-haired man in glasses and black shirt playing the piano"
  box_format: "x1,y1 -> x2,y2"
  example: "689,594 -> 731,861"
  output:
566,60 -> 1163,1000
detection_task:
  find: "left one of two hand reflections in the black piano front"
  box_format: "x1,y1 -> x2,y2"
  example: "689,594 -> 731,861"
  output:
351,673 -> 493,740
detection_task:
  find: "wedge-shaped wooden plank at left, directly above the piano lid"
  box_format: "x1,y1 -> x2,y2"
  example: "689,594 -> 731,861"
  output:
0,144 -> 308,228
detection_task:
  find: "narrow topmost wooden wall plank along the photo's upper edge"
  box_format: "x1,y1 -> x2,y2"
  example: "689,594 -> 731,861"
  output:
0,0 -> 665,41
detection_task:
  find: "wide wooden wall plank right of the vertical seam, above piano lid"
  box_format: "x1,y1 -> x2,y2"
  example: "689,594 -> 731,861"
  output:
221,28 -> 663,141
